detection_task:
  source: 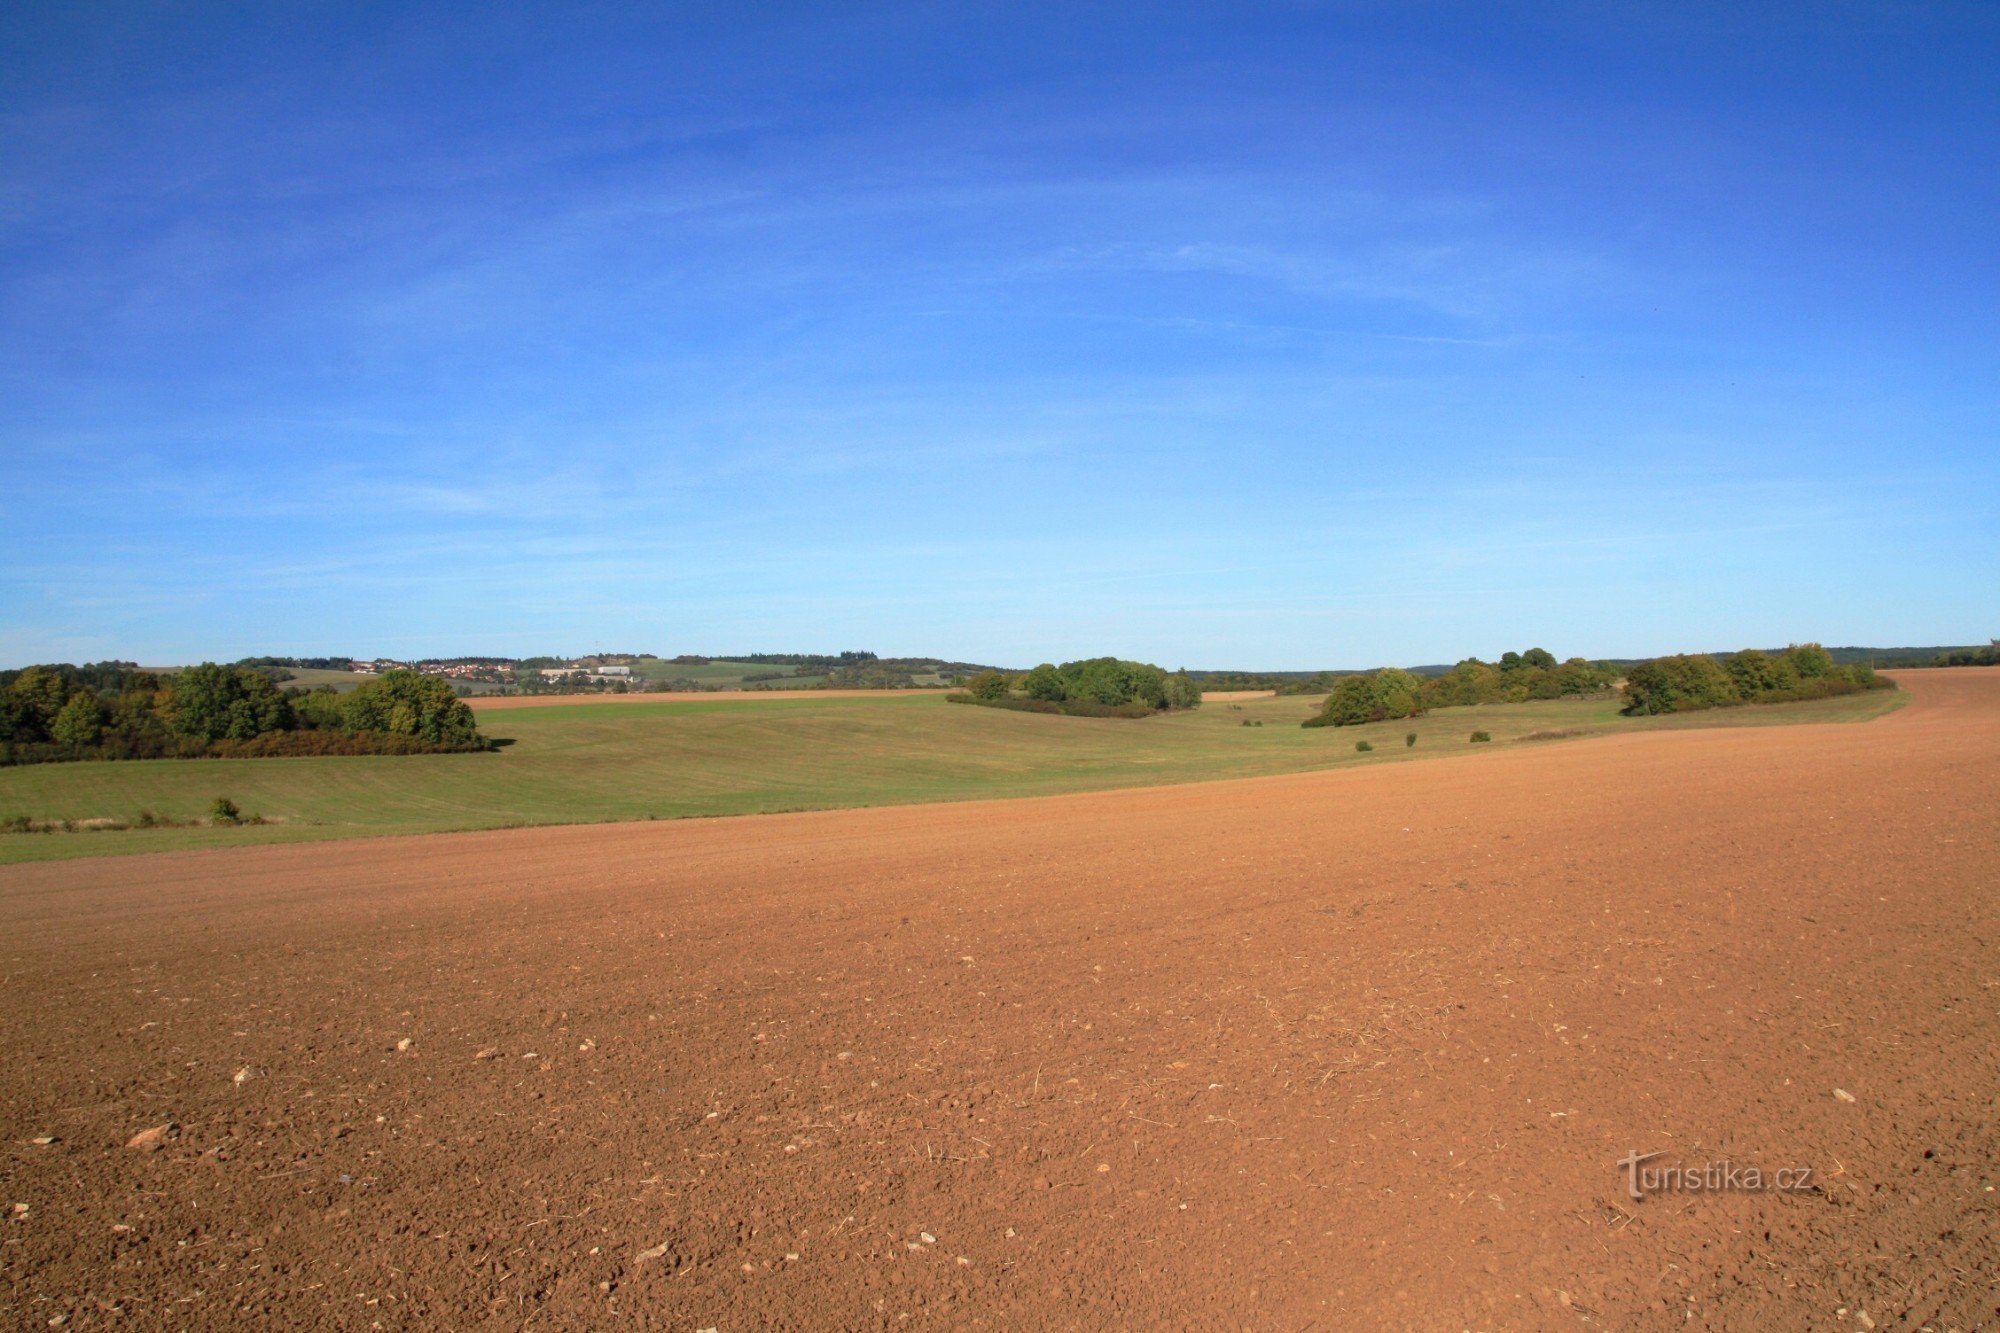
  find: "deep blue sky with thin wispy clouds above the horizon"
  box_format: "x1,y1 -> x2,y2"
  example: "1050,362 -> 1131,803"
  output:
0,0 -> 2000,669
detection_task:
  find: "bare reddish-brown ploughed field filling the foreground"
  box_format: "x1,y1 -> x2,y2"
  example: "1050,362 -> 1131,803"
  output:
0,671 -> 2000,1333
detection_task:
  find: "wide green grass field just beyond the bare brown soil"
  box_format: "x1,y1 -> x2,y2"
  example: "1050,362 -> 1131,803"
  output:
0,693 -> 1904,863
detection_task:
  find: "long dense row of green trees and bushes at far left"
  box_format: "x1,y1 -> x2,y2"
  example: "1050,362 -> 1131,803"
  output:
0,662 -> 486,765
